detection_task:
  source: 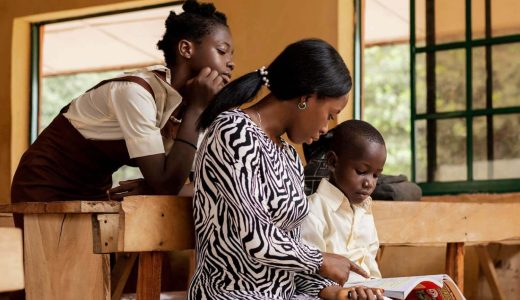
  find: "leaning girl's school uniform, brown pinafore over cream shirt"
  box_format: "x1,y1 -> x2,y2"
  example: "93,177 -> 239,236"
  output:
11,66 -> 182,203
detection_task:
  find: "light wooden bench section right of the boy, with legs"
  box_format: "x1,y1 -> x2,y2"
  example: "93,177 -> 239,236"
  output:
373,194 -> 520,299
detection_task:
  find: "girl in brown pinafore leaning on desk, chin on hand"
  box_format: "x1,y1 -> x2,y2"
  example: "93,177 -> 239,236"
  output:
11,1 -> 234,211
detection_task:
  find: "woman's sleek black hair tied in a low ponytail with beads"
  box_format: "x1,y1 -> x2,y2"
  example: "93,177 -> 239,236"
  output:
199,39 -> 352,130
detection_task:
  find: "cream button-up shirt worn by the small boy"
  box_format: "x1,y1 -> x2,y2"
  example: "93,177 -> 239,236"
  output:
301,179 -> 381,282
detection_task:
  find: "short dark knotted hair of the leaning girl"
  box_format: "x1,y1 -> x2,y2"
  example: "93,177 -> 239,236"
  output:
157,0 -> 228,66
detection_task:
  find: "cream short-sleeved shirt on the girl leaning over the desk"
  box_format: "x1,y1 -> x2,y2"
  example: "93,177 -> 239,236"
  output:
64,66 -> 182,158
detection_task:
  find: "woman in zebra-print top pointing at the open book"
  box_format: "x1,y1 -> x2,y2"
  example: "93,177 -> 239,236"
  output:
189,39 -> 382,299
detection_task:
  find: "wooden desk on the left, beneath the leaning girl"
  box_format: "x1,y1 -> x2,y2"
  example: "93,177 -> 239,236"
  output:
0,196 -> 194,300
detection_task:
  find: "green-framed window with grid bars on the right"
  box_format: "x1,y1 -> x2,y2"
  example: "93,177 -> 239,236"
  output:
410,0 -> 520,194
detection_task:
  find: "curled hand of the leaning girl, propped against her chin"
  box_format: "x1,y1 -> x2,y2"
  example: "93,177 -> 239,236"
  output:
183,67 -> 226,113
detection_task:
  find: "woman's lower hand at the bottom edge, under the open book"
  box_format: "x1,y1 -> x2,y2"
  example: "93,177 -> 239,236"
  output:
319,286 -> 384,300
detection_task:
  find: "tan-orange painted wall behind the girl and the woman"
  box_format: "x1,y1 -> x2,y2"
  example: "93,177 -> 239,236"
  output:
0,0 -> 353,203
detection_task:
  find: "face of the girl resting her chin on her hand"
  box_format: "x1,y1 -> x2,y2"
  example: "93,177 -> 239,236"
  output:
189,25 -> 235,84
